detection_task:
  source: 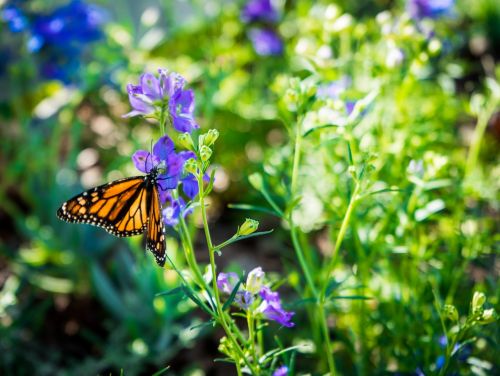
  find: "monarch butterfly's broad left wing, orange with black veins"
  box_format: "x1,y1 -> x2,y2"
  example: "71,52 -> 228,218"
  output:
57,176 -> 149,236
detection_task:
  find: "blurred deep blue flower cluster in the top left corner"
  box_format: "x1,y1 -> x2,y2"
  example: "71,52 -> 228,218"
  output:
0,0 -> 108,83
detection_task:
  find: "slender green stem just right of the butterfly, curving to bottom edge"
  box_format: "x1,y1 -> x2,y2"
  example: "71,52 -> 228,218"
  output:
198,172 -> 258,375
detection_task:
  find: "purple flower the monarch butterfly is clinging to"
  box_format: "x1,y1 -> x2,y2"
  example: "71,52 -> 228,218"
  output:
132,136 -> 184,204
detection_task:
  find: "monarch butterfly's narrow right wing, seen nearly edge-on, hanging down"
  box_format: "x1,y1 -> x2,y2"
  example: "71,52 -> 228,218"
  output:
146,184 -> 166,266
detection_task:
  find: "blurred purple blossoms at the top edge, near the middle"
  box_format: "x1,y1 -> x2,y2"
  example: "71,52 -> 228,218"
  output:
241,0 -> 283,56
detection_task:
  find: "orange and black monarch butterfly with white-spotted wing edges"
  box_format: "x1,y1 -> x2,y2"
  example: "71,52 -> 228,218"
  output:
57,167 -> 166,266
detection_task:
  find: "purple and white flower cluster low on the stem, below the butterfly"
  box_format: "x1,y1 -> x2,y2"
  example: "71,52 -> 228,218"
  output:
217,267 -> 295,328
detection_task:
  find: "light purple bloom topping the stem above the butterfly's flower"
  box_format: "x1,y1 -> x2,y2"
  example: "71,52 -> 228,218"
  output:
124,69 -> 199,133
